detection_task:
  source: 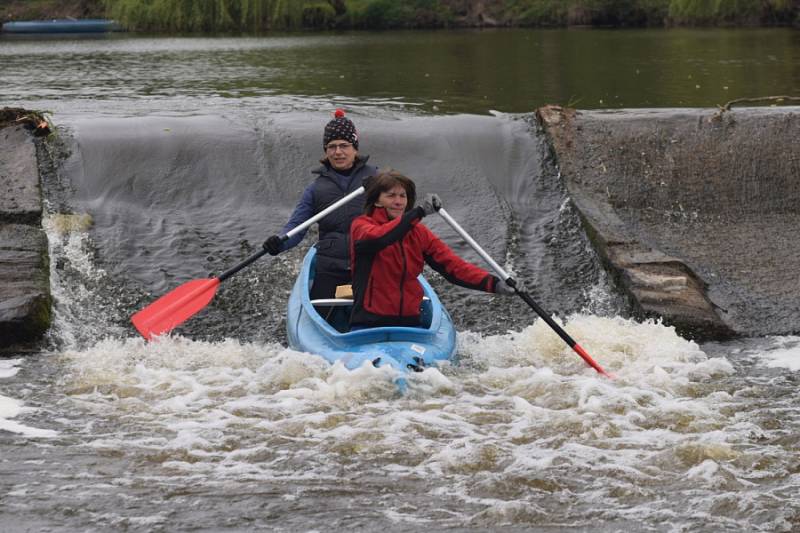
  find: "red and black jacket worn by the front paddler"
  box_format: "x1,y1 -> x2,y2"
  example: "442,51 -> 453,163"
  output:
350,207 -> 498,326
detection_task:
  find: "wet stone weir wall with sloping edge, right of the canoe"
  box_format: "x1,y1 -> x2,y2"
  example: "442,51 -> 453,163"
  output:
536,106 -> 800,341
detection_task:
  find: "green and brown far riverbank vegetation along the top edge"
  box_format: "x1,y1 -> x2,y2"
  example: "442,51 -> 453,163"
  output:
0,0 -> 800,32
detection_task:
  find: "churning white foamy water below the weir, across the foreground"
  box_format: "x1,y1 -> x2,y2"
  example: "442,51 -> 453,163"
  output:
7,211 -> 798,531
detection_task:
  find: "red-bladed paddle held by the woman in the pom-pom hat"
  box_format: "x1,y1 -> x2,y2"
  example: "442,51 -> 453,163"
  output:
131,187 -> 364,340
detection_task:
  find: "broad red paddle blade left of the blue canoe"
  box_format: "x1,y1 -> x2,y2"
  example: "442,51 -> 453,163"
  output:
131,278 -> 219,340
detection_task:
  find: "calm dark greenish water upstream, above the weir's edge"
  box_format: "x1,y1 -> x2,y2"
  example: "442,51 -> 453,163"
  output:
0,28 -> 800,114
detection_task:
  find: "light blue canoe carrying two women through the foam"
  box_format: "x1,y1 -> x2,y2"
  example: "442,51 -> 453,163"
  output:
286,247 -> 456,384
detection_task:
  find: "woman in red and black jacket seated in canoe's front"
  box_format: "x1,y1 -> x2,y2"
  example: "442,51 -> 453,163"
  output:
350,169 -> 514,329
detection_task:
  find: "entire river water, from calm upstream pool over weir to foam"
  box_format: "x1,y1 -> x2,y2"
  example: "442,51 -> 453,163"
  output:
0,29 -> 800,532
